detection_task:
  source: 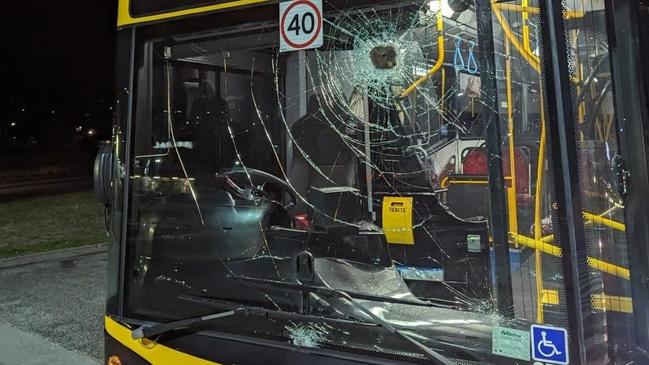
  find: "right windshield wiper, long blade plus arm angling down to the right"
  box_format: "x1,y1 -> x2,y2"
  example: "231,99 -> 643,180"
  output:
235,276 -> 455,365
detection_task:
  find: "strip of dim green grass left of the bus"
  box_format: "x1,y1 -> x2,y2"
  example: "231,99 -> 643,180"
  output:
0,192 -> 106,258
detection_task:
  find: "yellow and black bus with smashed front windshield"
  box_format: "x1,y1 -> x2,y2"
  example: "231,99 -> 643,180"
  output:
95,0 -> 649,365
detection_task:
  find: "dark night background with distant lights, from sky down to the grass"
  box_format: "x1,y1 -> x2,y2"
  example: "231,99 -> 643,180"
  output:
0,0 -> 117,183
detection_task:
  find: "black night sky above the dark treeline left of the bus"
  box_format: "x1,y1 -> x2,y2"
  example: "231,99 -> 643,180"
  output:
0,0 -> 117,150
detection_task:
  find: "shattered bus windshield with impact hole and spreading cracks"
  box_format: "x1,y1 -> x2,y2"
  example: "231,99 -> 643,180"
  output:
119,1 -> 636,363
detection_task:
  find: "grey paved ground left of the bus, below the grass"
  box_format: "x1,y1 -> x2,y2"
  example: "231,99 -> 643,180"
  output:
0,249 -> 106,365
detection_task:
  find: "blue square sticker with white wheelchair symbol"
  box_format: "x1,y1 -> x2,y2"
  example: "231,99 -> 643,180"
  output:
530,325 -> 569,365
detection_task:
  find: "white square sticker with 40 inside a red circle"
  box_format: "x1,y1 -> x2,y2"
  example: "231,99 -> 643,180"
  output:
279,0 -> 323,52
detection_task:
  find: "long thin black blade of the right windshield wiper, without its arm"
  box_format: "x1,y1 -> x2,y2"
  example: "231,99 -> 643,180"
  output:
231,276 -> 437,307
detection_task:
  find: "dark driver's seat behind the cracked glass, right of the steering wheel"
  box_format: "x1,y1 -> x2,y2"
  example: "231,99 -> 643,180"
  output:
289,95 -> 358,223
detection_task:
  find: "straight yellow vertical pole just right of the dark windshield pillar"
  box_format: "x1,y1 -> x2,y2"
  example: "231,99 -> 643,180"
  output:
505,40 -> 519,236
